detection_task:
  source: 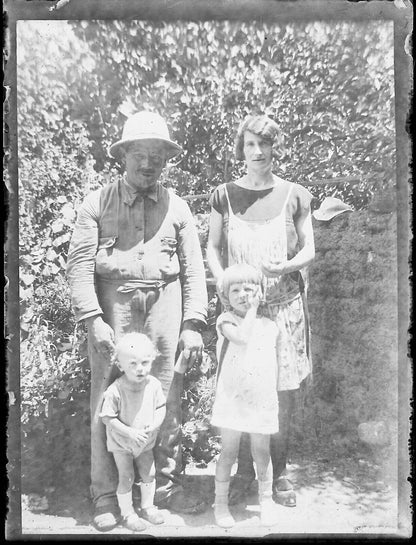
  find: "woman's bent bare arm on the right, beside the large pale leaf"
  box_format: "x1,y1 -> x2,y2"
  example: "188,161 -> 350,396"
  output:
262,210 -> 315,277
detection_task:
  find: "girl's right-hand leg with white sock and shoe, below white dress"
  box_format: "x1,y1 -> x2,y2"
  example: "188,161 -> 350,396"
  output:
250,433 -> 276,526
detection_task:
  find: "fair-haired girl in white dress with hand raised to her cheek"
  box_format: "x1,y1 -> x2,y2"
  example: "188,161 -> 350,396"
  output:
211,264 -> 279,528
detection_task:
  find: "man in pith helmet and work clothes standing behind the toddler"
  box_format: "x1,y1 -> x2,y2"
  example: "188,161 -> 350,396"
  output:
67,112 -> 207,531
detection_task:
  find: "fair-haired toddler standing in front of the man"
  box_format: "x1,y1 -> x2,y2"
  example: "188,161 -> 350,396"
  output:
100,333 -> 166,532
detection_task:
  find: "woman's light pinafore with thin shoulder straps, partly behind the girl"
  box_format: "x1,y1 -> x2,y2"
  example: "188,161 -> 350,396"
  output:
219,184 -> 311,391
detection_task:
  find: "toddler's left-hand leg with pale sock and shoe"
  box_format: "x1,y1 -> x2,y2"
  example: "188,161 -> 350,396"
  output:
113,452 -> 146,532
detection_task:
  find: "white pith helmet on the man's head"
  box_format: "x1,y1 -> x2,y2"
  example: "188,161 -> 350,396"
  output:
108,111 -> 182,159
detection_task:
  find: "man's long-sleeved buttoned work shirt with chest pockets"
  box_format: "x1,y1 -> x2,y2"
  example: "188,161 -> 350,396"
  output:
67,181 -> 207,322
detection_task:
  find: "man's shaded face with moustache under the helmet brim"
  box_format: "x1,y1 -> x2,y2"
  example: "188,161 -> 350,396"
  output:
125,140 -> 166,190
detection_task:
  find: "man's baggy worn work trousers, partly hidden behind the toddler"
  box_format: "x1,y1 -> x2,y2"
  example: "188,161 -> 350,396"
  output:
88,280 -> 182,507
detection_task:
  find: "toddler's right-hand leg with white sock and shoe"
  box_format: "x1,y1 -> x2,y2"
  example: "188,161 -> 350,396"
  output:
134,449 -> 165,524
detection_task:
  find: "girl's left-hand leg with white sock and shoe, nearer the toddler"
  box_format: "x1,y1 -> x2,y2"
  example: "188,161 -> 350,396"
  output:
214,428 -> 241,528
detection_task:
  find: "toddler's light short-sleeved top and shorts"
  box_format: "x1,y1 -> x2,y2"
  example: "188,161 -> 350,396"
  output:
100,375 -> 166,455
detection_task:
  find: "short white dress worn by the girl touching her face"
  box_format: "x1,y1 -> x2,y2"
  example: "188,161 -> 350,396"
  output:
211,312 -> 279,435
